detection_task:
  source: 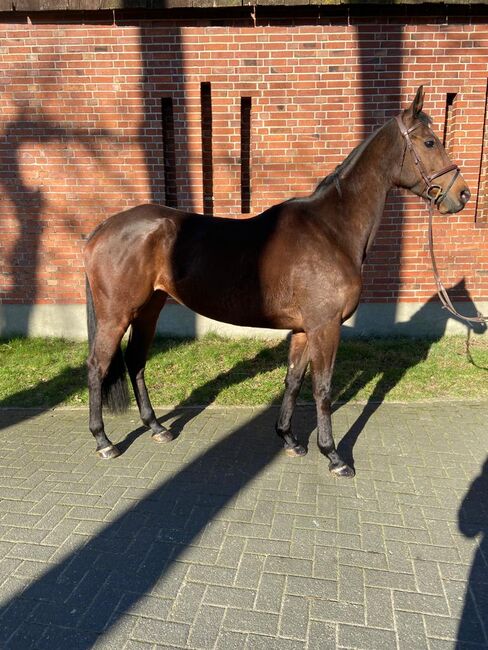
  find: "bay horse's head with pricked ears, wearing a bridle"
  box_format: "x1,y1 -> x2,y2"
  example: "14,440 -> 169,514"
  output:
396,86 -> 471,214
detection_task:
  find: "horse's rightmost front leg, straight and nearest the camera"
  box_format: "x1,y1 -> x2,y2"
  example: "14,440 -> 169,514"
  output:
308,318 -> 354,477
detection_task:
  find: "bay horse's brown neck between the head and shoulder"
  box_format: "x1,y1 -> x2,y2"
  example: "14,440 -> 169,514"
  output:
326,121 -> 399,267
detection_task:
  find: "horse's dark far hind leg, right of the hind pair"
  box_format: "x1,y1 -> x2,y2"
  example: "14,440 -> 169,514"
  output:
125,291 -> 173,442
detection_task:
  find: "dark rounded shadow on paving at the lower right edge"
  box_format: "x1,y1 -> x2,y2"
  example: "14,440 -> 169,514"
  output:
456,459 -> 488,650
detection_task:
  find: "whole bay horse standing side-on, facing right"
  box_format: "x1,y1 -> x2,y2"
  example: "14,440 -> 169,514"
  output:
85,86 -> 470,477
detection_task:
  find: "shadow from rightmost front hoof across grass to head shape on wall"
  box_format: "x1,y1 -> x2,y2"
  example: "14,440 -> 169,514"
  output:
338,278 -> 486,467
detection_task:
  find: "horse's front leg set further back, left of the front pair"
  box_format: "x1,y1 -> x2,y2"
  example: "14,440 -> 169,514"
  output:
276,332 -> 310,456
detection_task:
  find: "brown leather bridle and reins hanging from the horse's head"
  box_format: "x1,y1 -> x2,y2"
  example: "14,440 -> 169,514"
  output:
395,115 -> 488,326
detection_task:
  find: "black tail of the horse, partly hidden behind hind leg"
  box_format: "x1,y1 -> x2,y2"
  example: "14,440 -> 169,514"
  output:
86,278 -> 130,413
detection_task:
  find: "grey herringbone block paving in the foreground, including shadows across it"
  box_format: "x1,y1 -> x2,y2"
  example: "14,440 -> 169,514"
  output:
0,404 -> 488,650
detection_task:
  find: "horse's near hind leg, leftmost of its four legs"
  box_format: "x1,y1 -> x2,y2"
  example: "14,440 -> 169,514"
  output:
87,323 -> 125,459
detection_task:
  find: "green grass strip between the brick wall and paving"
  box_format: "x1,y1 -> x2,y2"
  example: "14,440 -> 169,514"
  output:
0,335 -> 488,407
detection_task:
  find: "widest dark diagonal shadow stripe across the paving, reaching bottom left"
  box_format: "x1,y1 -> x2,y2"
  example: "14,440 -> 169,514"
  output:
0,388 -> 315,650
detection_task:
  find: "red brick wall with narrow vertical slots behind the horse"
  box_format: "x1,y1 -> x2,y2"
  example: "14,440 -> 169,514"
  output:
0,9 -> 488,303
